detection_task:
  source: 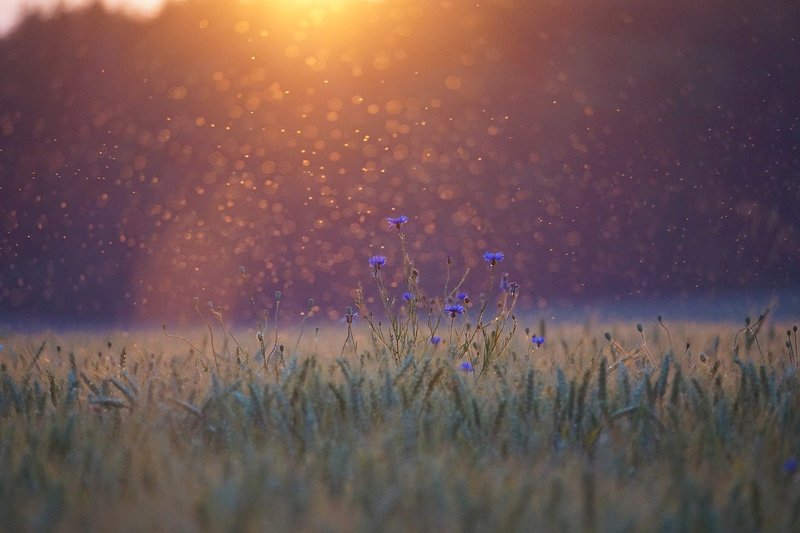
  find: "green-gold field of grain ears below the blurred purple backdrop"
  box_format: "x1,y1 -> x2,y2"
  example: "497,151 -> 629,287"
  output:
0,314 -> 800,531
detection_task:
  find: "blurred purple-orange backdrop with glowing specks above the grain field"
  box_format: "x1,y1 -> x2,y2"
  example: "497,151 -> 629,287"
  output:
0,0 -> 800,324
